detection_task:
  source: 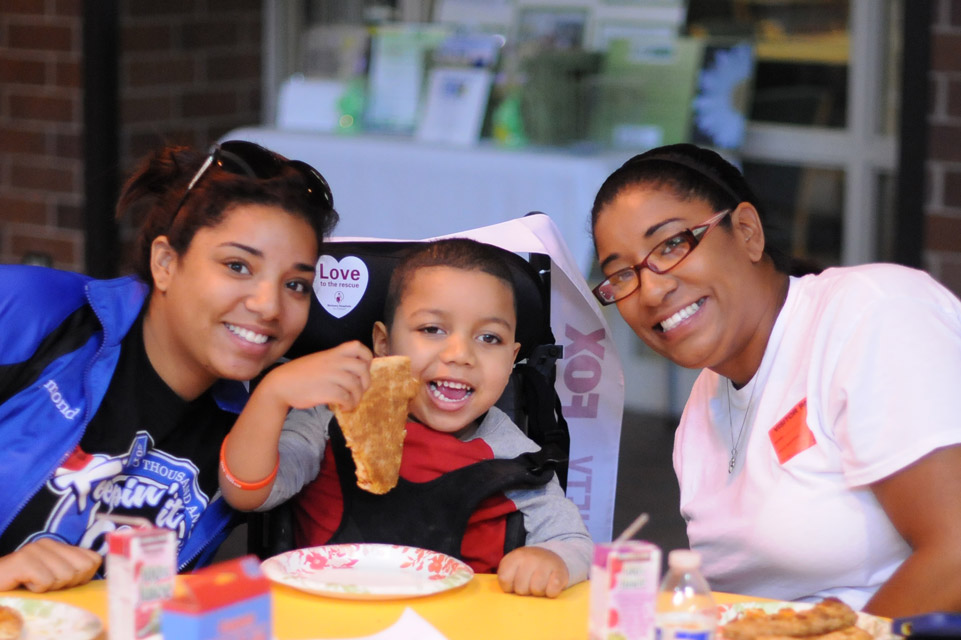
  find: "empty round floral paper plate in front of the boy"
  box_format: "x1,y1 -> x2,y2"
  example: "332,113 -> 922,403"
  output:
261,544 -> 474,600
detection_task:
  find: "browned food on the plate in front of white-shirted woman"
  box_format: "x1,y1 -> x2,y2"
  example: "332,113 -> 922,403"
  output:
721,598 -> 872,640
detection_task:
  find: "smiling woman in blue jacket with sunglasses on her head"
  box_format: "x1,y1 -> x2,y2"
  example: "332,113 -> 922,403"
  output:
0,141 -> 370,591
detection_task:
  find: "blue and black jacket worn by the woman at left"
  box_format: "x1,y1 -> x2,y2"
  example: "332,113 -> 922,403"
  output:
0,265 -> 247,569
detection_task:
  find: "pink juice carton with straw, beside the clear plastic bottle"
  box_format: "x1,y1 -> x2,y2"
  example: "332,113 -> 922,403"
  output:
589,540 -> 661,640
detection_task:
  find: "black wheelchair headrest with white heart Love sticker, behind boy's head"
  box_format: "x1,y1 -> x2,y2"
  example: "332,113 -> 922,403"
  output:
287,240 -> 554,361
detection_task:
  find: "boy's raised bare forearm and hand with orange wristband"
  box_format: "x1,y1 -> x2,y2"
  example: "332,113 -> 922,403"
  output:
218,341 -> 372,511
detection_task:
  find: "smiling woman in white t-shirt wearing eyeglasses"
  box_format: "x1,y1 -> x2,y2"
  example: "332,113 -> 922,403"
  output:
592,144 -> 961,616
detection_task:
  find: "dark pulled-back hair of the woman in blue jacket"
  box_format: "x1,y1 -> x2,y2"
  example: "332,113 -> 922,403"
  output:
116,146 -> 339,286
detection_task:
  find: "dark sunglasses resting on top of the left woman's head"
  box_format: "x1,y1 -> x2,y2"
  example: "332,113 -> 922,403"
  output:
171,140 -> 334,219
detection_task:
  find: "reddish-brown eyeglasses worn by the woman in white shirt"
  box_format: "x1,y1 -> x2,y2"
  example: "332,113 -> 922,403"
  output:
591,209 -> 734,305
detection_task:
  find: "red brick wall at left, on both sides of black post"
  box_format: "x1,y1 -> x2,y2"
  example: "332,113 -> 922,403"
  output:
0,0 -> 262,271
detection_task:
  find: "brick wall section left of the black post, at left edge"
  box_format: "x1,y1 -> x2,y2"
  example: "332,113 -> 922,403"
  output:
0,0 -> 83,269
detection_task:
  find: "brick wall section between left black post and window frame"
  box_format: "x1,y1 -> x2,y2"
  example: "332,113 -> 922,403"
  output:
120,0 -> 261,169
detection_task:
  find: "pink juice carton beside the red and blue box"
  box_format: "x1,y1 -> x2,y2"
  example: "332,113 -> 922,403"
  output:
107,527 -> 177,640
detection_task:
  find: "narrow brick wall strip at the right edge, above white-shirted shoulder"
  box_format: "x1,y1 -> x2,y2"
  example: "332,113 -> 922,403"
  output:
924,0 -> 961,294
